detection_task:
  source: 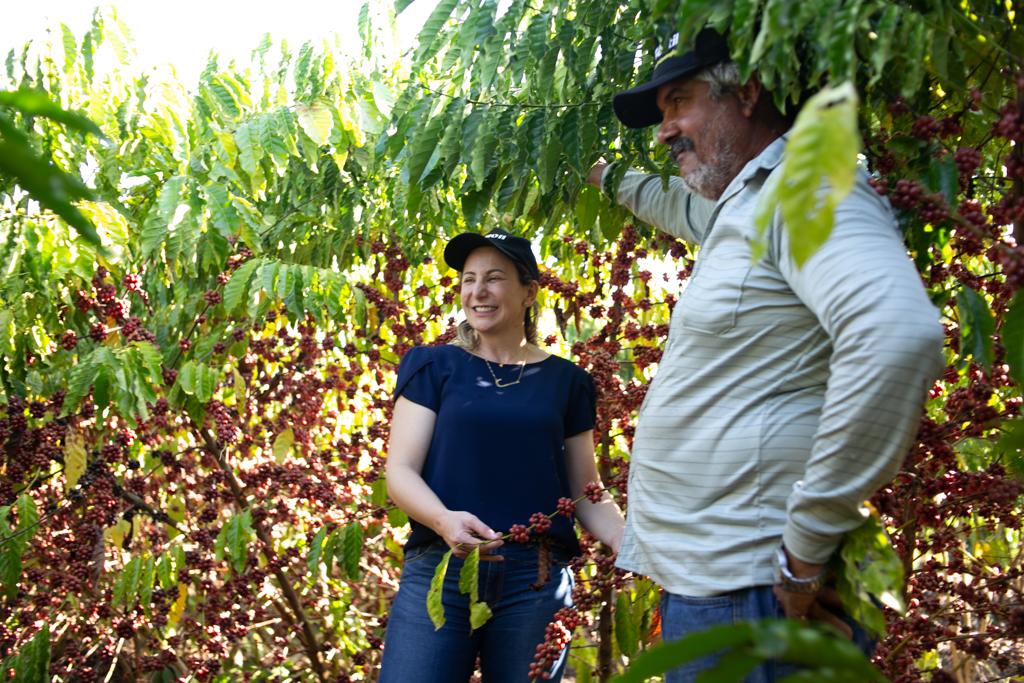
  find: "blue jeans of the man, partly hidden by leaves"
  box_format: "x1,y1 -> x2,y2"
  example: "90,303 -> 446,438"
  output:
662,586 -> 873,683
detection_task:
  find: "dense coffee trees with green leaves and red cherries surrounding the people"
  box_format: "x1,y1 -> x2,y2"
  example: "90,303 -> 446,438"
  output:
0,0 -> 1024,681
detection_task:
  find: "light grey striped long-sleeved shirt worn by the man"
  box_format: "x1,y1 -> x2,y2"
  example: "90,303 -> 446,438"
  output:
617,138 -> 943,596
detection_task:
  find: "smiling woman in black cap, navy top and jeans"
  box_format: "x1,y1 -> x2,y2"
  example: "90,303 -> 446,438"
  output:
380,229 -> 623,683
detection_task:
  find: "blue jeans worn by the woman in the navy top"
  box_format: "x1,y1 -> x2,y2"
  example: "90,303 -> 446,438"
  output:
379,542 -> 572,683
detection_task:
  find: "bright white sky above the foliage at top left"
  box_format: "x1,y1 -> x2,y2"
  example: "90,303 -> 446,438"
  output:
0,0 -> 437,85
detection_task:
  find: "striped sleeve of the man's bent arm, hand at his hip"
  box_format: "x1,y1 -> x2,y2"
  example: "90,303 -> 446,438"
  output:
771,178 -> 943,563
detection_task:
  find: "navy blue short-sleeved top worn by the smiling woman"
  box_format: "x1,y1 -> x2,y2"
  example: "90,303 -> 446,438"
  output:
394,345 -> 596,554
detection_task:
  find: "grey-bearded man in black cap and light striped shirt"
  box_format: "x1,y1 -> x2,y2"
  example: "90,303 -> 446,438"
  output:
589,29 -> 943,683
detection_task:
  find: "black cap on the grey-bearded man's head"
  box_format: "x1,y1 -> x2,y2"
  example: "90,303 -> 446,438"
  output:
612,29 -> 729,128
